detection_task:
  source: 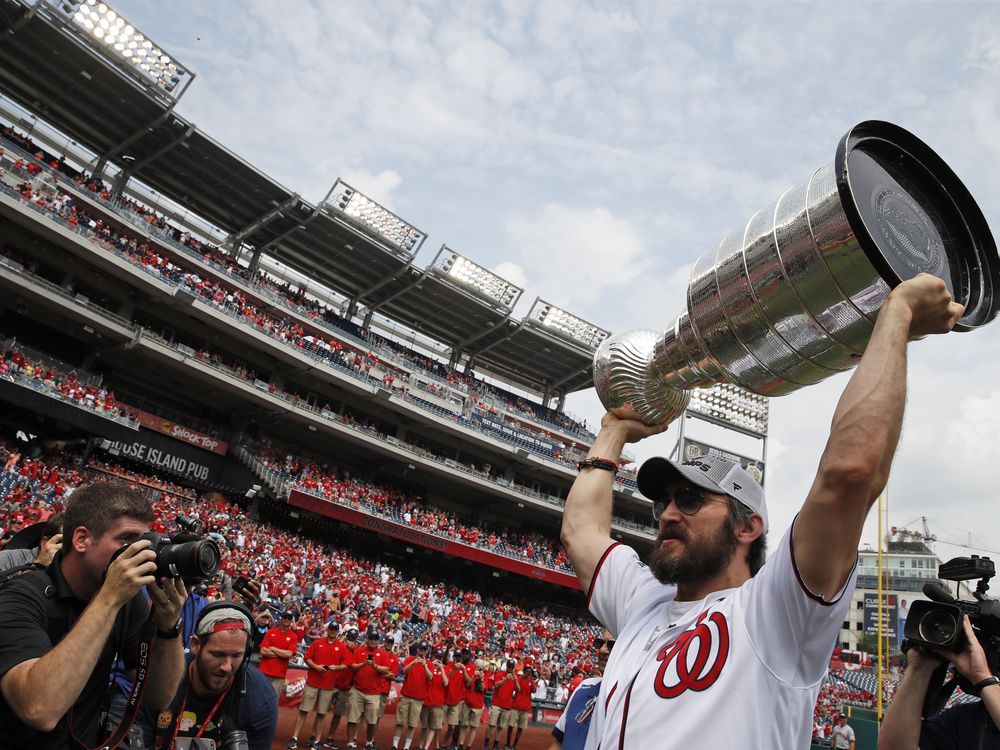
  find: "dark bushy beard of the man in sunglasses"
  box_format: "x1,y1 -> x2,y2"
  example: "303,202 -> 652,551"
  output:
649,516 -> 739,585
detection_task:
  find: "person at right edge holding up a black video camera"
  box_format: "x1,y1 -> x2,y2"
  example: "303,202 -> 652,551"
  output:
878,615 -> 1000,750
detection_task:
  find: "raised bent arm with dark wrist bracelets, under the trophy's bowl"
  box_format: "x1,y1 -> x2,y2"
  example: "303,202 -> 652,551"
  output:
560,414 -> 668,592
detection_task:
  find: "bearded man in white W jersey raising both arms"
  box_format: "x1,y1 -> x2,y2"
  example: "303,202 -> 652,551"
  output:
562,274 -> 964,750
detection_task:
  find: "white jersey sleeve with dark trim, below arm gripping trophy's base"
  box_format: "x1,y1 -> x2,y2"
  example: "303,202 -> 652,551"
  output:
740,522 -> 858,685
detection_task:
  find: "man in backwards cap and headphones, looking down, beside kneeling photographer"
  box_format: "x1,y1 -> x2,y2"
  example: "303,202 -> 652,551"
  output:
139,601 -> 278,750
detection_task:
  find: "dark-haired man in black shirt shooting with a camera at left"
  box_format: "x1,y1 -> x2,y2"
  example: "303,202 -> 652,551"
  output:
0,482 -> 187,748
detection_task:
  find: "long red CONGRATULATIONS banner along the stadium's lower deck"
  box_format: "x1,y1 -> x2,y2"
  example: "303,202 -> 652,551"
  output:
288,490 -> 580,589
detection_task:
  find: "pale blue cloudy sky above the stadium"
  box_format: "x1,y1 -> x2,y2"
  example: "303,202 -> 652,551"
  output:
113,0 -> 1000,556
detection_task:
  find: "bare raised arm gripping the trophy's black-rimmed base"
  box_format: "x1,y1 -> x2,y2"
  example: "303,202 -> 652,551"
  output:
792,274 -> 964,601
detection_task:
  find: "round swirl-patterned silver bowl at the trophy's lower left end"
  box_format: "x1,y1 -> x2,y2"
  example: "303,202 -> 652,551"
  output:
594,330 -> 691,424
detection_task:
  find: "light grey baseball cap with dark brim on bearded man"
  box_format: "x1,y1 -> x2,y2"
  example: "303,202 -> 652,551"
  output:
636,454 -> 768,533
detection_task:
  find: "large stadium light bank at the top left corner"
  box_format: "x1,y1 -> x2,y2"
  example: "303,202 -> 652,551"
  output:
48,0 -> 194,98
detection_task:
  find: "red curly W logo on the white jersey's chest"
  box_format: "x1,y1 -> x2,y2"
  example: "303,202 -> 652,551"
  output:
653,612 -> 729,698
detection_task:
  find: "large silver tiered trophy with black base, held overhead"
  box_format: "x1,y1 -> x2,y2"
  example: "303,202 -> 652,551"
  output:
594,121 -> 1000,424
